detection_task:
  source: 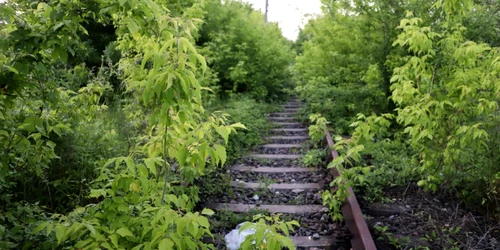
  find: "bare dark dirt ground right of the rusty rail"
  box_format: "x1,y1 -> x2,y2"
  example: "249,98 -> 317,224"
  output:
359,184 -> 500,250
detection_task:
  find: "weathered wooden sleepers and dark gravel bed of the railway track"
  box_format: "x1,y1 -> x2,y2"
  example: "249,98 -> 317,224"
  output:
205,99 -> 371,250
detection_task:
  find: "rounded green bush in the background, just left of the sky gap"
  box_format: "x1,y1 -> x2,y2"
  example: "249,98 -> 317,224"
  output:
198,0 -> 293,100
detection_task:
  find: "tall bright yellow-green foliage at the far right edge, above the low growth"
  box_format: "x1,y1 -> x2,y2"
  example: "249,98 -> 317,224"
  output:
391,8 -> 500,207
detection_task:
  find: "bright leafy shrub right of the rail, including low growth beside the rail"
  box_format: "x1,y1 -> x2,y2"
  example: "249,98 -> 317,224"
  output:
316,0 -> 500,218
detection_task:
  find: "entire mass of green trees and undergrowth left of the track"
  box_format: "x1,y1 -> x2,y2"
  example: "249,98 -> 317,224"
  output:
0,0 -> 292,249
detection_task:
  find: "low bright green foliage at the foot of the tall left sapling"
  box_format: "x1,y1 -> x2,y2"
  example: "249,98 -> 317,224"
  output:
35,157 -> 217,249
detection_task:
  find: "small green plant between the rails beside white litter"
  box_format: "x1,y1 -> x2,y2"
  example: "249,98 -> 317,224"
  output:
240,214 -> 300,250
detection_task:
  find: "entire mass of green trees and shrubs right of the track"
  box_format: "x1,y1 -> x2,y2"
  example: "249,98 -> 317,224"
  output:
294,0 -> 500,225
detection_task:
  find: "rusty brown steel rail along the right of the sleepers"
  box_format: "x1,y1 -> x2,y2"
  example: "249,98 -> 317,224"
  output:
325,128 -> 377,250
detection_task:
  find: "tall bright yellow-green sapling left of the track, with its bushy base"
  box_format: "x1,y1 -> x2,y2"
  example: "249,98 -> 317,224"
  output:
37,1 -> 242,249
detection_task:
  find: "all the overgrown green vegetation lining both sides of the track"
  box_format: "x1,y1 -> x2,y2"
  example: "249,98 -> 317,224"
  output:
0,0 -> 500,249
